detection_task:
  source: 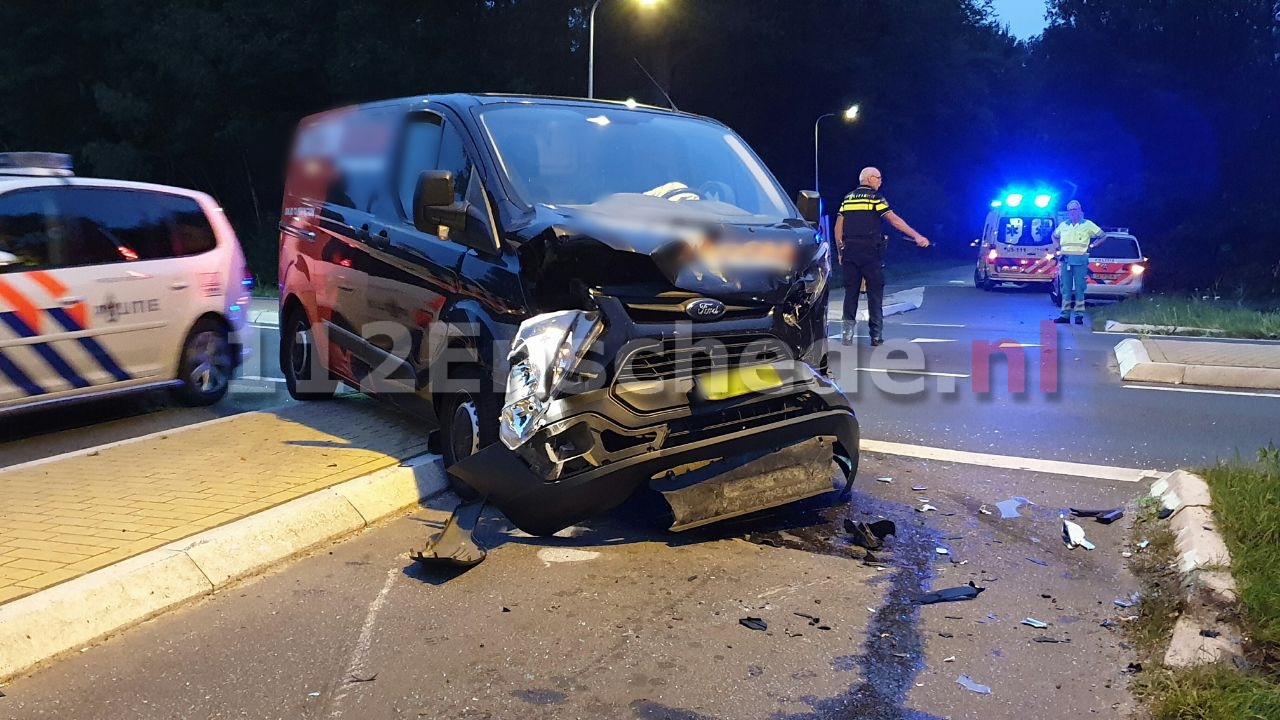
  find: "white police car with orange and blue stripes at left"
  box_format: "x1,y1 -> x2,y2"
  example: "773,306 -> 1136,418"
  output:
0,152 -> 252,415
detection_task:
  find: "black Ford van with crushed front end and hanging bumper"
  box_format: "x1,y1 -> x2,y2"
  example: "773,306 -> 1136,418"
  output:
279,95 -> 859,534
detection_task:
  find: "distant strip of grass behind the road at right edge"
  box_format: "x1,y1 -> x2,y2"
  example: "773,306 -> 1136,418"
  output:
1089,295 -> 1280,340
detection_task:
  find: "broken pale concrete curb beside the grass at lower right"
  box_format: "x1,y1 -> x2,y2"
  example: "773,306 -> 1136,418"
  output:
1151,470 -> 1240,667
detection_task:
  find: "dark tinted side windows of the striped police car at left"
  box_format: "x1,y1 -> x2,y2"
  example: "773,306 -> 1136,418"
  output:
0,187 -> 216,272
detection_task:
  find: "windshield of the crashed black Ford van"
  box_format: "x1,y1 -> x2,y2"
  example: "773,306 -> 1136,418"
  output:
480,105 -> 797,222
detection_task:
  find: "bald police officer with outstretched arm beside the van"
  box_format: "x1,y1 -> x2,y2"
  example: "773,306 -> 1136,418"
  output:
835,168 -> 929,345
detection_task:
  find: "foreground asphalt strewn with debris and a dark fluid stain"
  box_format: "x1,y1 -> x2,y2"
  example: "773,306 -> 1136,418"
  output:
0,456 -> 1139,720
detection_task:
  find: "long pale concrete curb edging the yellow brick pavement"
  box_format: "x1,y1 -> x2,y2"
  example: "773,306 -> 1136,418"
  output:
0,455 -> 448,680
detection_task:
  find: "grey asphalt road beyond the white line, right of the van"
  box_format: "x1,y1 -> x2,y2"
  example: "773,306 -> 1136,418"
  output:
832,265 -> 1280,469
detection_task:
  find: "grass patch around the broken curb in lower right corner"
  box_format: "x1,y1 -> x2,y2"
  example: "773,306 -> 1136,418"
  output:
1129,446 -> 1280,720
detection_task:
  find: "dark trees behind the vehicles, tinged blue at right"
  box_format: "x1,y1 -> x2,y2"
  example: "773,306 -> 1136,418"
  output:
0,0 -> 1280,296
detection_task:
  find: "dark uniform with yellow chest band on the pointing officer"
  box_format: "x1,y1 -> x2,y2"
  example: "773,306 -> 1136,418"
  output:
840,184 -> 890,338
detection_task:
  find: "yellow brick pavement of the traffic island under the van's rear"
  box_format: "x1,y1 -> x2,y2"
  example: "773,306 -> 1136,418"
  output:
0,396 -> 426,602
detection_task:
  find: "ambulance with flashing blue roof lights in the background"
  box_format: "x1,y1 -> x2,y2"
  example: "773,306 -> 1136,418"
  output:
973,192 -> 1061,290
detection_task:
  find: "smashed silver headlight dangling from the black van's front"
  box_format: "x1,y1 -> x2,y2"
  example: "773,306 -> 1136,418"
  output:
498,310 -> 604,450
